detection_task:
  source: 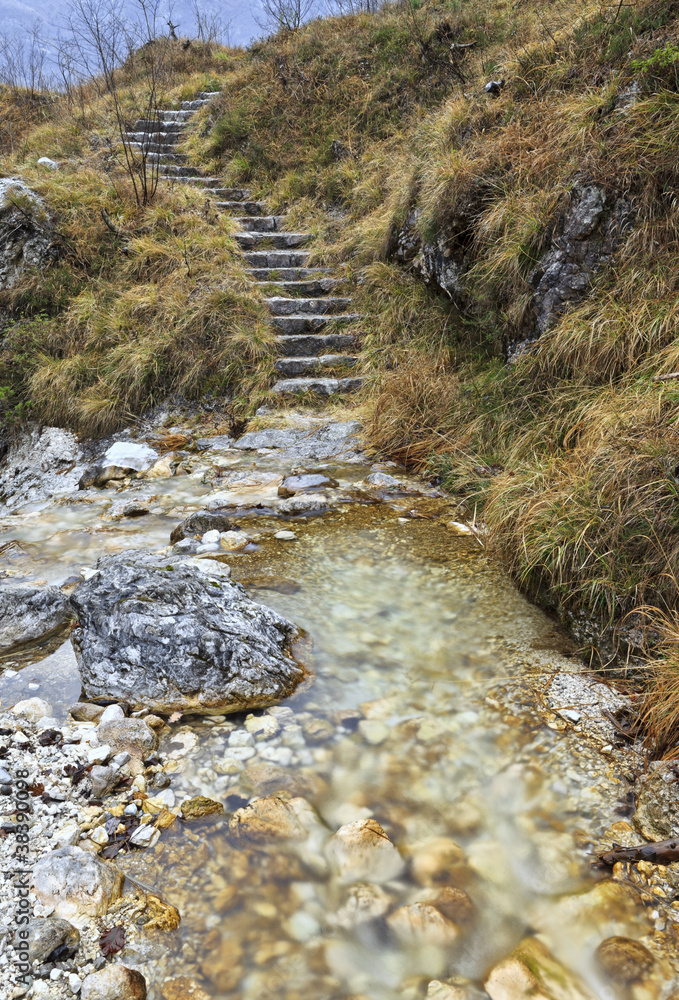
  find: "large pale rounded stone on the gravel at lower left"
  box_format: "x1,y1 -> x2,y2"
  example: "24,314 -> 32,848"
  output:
32,847 -> 125,921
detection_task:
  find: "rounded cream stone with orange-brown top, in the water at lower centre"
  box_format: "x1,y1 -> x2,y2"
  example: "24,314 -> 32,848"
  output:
326,819 -> 405,883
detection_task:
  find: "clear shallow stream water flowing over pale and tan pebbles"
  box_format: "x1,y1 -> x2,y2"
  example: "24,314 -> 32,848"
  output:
0,432 -> 660,1000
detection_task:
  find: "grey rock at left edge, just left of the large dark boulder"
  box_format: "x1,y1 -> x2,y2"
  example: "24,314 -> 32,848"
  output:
0,583 -> 73,652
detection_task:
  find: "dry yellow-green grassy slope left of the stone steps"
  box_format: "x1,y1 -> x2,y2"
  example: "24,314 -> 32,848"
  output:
0,44 -> 271,435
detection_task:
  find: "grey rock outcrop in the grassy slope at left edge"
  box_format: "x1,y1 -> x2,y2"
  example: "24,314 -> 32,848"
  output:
0,177 -> 60,289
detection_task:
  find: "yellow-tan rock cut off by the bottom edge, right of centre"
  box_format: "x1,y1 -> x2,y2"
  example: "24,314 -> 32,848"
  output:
484,938 -> 594,1000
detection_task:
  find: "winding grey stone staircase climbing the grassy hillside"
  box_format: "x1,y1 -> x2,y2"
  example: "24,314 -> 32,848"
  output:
126,92 -> 363,396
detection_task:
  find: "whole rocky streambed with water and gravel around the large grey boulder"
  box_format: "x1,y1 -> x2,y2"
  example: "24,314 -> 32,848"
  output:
0,410 -> 677,1000
